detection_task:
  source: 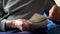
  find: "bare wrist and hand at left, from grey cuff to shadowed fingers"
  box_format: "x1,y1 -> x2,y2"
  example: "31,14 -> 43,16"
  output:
6,19 -> 38,31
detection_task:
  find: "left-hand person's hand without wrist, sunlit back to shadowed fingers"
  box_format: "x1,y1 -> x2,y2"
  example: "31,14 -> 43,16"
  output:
14,19 -> 38,31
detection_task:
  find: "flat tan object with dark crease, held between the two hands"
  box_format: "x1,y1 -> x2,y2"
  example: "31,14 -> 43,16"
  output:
30,13 -> 48,28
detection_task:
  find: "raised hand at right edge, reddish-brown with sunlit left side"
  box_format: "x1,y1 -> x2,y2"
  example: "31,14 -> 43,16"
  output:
48,5 -> 60,21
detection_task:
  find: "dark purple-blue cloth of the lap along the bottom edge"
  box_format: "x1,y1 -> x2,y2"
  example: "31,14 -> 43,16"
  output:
0,29 -> 47,34
